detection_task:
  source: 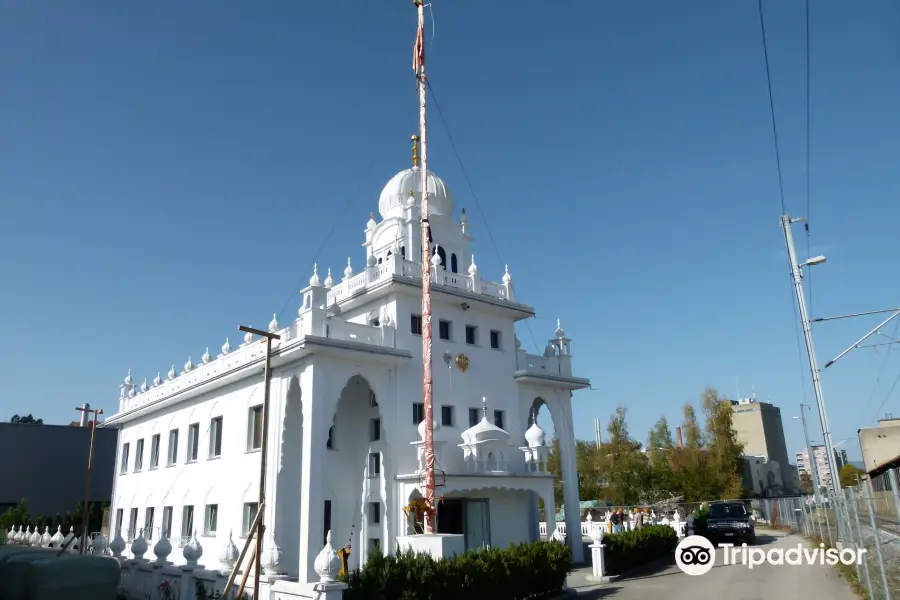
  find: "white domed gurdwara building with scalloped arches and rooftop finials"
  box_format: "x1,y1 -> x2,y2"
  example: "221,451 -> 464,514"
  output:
103,154 -> 590,581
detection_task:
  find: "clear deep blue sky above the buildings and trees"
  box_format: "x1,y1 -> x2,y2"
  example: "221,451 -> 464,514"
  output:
0,0 -> 900,464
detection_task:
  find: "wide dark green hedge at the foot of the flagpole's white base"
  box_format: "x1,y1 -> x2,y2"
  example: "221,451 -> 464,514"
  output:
344,541 -> 570,600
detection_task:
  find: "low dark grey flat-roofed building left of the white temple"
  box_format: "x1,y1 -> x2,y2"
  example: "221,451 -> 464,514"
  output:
0,423 -> 119,517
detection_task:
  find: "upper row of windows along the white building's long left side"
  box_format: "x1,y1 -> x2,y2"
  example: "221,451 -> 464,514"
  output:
119,405 -> 262,475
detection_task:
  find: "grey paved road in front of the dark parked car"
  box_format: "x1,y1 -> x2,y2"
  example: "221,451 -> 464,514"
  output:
569,534 -> 858,600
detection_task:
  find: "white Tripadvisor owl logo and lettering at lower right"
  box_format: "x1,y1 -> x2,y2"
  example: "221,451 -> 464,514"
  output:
675,535 -> 866,576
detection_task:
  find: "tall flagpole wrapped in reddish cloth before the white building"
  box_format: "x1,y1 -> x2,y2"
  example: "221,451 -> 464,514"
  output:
413,0 -> 435,533
